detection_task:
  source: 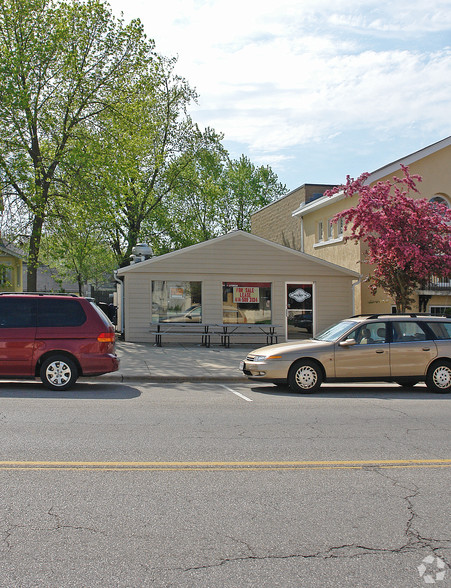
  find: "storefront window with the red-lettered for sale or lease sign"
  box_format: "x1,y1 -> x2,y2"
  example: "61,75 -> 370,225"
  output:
222,282 -> 271,324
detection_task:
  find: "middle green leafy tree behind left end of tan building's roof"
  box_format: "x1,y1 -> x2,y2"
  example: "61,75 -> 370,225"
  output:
77,57 -> 216,265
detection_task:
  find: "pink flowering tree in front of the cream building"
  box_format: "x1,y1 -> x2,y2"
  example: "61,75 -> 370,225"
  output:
327,166 -> 451,312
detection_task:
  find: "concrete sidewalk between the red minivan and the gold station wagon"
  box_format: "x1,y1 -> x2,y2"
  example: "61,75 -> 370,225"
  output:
98,341 -> 254,382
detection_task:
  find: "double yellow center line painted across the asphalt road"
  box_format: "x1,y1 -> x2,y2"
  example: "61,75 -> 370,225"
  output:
0,459 -> 451,471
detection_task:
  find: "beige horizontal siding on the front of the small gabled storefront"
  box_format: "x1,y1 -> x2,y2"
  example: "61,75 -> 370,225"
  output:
119,233 -> 356,343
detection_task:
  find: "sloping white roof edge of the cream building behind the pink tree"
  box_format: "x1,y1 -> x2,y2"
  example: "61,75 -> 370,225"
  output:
292,136 -> 451,216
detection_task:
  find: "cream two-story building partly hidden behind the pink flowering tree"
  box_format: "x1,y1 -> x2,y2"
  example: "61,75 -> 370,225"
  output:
252,137 -> 451,313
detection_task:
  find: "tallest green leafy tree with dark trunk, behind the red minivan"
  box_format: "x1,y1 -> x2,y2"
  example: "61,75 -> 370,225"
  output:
0,0 -> 153,290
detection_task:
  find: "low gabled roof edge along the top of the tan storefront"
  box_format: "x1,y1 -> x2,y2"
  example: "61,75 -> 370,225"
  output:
117,231 -> 360,278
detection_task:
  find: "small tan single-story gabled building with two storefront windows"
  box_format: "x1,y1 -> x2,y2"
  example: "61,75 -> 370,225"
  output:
117,231 -> 359,343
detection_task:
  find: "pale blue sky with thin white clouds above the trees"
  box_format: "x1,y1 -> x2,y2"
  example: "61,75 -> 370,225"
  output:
110,0 -> 451,190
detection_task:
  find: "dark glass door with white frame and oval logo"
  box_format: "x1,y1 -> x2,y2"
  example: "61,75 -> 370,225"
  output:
285,284 -> 314,339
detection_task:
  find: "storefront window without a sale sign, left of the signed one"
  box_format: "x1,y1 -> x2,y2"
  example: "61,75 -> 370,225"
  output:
152,280 -> 202,323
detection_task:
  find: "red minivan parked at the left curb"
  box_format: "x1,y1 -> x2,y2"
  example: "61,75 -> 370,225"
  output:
0,293 -> 119,390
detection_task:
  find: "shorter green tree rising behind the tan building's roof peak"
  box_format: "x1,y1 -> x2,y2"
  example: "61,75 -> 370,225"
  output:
155,152 -> 286,251
